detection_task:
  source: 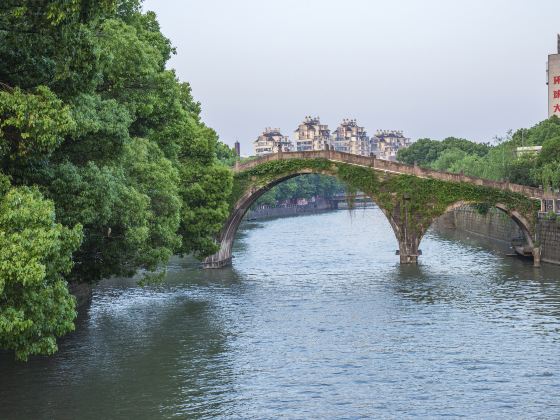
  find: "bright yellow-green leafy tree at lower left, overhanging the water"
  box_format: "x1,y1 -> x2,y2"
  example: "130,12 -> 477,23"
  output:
0,187 -> 82,360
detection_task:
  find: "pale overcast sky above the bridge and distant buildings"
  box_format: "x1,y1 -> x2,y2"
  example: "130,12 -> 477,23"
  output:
144,0 -> 560,154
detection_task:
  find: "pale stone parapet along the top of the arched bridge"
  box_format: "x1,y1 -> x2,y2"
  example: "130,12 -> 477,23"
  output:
234,150 -> 560,199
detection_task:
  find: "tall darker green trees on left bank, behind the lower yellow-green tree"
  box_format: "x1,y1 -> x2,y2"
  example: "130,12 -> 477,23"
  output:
0,0 -> 231,281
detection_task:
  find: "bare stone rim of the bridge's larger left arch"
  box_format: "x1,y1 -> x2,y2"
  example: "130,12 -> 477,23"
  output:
203,168 -> 401,268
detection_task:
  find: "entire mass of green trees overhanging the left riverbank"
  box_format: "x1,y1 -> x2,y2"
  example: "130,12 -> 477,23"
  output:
0,0 -> 232,358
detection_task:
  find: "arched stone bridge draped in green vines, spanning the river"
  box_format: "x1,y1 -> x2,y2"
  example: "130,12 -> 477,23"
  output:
204,150 -> 550,268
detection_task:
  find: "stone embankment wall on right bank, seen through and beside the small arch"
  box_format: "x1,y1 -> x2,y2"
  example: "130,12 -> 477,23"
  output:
433,206 -> 560,264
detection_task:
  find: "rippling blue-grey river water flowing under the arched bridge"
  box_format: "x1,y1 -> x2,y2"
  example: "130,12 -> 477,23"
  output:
0,209 -> 560,419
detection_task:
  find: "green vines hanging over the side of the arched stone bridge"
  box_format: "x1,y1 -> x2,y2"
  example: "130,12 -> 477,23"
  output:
230,159 -> 538,237
